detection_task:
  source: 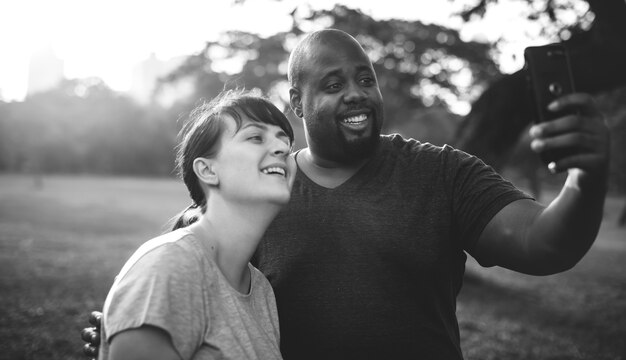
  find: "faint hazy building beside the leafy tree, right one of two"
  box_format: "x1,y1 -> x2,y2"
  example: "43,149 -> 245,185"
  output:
129,53 -> 193,106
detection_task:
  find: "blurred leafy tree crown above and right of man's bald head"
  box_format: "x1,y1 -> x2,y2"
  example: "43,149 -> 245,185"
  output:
291,5 -> 500,131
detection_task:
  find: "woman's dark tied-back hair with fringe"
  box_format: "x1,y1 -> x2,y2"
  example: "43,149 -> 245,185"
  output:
172,89 -> 294,230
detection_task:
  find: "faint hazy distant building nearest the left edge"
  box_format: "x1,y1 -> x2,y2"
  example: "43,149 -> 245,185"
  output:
26,48 -> 64,96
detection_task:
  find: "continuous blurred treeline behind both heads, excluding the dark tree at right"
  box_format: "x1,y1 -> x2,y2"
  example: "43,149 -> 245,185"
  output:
0,5 -> 498,175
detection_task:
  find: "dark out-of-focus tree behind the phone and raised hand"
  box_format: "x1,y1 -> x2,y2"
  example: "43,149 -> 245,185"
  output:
455,0 -> 626,197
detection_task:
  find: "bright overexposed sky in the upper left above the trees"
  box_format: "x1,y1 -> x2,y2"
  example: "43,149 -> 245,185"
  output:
0,0 -> 290,100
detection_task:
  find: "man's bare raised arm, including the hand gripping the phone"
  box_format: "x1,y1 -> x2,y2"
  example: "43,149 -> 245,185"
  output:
472,94 -> 609,275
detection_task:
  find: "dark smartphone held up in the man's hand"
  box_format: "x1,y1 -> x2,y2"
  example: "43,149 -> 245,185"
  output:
524,44 -> 575,164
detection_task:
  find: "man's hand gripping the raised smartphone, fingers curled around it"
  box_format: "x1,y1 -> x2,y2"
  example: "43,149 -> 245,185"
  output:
530,93 -> 610,181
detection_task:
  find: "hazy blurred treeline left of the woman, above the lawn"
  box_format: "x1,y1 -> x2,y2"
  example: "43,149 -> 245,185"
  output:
0,79 -> 176,174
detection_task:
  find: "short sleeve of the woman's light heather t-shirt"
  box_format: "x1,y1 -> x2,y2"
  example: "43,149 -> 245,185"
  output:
104,243 -> 207,359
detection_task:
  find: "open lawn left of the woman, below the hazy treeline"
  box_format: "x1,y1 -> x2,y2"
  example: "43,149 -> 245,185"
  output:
0,176 -> 188,360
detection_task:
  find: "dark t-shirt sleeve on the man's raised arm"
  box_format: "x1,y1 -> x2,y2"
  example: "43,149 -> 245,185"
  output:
446,147 -> 532,255
